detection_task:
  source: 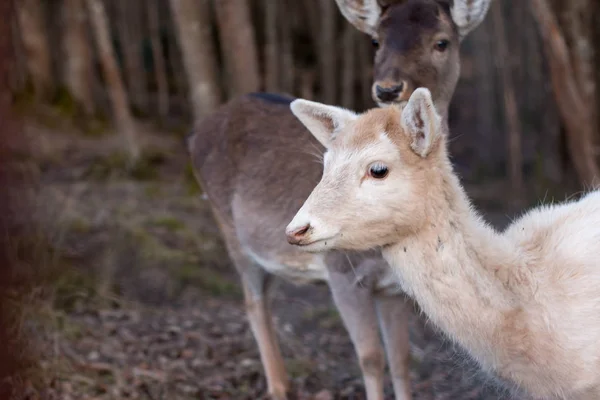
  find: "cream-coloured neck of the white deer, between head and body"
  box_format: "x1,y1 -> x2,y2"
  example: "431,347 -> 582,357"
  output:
383,164 -> 522,370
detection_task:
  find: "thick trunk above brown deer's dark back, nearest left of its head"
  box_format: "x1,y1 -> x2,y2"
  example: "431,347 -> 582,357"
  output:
215,0 -> 260,96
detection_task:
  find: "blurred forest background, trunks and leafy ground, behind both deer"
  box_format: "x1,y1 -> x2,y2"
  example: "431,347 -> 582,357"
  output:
9,0 -> 600,399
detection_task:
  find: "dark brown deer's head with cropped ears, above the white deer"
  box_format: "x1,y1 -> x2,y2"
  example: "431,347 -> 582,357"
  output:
336,0 -> 491,112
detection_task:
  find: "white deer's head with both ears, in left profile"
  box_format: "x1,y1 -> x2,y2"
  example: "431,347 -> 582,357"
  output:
286,88 -> 449,251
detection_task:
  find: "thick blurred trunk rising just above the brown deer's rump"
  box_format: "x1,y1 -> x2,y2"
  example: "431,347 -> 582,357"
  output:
170,0 -> 221,118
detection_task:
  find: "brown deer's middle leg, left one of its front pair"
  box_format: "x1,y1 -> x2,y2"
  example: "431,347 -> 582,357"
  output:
328,257 -> 385,400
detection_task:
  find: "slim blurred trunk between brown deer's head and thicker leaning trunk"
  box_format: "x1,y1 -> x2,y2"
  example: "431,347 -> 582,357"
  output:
491,1 -> 523,200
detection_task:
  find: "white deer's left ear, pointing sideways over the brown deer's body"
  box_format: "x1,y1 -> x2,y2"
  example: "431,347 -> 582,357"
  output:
290,99 -> 357,148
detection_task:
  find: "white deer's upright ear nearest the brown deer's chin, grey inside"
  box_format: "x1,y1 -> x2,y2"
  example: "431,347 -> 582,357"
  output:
401,88 -> 441,157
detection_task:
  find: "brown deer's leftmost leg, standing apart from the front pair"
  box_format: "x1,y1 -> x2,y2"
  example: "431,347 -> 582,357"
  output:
242,265 -> 289,400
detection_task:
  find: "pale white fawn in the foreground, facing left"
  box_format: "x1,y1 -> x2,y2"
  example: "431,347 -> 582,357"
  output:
282,88 -> 600,400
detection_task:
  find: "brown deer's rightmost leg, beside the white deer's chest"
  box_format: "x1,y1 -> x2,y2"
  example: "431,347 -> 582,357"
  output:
377,296 -> 412,400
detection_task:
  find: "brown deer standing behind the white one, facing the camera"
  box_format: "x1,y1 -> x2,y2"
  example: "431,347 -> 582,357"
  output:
188,0 -> 490,400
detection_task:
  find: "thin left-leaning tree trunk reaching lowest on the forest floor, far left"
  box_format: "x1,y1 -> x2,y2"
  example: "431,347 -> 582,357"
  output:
86,0 -> 140,163
